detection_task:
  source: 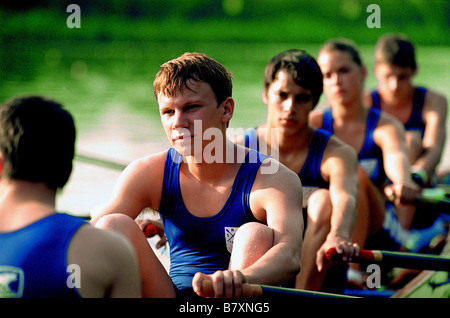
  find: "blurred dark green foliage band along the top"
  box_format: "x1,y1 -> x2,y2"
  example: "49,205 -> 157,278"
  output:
0,0 -> 450,45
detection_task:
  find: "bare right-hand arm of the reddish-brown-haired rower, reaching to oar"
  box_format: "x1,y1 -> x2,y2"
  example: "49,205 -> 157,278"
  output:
242,159 -> 304,285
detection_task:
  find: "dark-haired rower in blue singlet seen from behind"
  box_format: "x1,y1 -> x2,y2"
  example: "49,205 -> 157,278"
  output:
0,96 -> 140,298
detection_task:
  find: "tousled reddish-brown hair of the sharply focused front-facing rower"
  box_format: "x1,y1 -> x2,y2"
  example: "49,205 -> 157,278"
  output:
153,53 -> 233,104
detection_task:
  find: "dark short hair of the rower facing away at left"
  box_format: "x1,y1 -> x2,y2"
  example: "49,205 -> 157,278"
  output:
0,95 -> 76,189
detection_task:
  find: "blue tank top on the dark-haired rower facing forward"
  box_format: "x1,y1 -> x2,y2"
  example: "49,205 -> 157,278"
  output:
244,128 -> 331,208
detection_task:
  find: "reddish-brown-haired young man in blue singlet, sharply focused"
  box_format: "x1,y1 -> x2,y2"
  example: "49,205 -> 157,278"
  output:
93,53 -> 303,297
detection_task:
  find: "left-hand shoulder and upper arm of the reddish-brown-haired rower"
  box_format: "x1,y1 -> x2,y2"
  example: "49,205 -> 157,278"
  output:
91,152 -> 166,225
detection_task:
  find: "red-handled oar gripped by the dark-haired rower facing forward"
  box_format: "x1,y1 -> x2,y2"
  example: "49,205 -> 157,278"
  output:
326,247 -> 450,272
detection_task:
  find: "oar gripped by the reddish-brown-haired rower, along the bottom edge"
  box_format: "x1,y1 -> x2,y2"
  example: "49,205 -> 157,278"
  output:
197,280 -> 359,298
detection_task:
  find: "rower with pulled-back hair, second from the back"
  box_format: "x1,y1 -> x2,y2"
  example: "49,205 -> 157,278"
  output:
311,39 -> 419,252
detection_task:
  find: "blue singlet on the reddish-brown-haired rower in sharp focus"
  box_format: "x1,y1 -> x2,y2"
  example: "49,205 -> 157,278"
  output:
159,148 -> 267,291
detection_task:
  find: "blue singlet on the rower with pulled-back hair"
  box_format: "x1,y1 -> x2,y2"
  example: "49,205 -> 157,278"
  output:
322,107 -> 387,186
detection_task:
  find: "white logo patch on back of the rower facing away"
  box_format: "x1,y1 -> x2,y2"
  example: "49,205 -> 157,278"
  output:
0,266 -> 25,298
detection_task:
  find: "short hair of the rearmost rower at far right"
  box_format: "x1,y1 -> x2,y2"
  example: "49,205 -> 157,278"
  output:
375,34 -> 417,69
